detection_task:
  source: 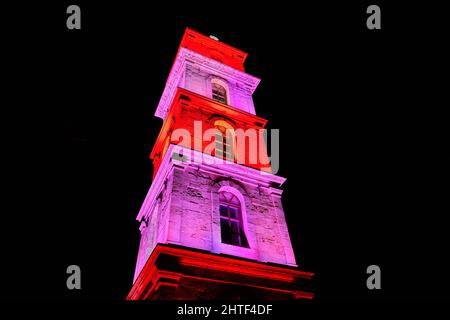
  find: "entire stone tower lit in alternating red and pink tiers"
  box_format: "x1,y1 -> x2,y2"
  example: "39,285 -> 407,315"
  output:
127,29 -> 312,299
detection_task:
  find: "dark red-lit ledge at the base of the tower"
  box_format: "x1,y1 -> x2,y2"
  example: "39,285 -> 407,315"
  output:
127,244 -> 314,300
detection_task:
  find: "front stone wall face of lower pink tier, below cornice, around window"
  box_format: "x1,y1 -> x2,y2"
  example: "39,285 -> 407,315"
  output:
167,166 -> 295,265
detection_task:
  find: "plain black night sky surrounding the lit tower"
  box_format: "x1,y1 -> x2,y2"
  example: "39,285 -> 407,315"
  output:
2,1 -> 449,303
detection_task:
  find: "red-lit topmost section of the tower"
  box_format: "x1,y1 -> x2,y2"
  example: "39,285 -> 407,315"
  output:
180,28 -> 247,71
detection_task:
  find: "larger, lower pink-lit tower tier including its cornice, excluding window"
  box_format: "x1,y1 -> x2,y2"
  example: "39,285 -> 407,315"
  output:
135,145 -> 296,277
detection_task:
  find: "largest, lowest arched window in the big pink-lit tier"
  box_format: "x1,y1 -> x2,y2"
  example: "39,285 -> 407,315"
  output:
219,191 -> 249,248
